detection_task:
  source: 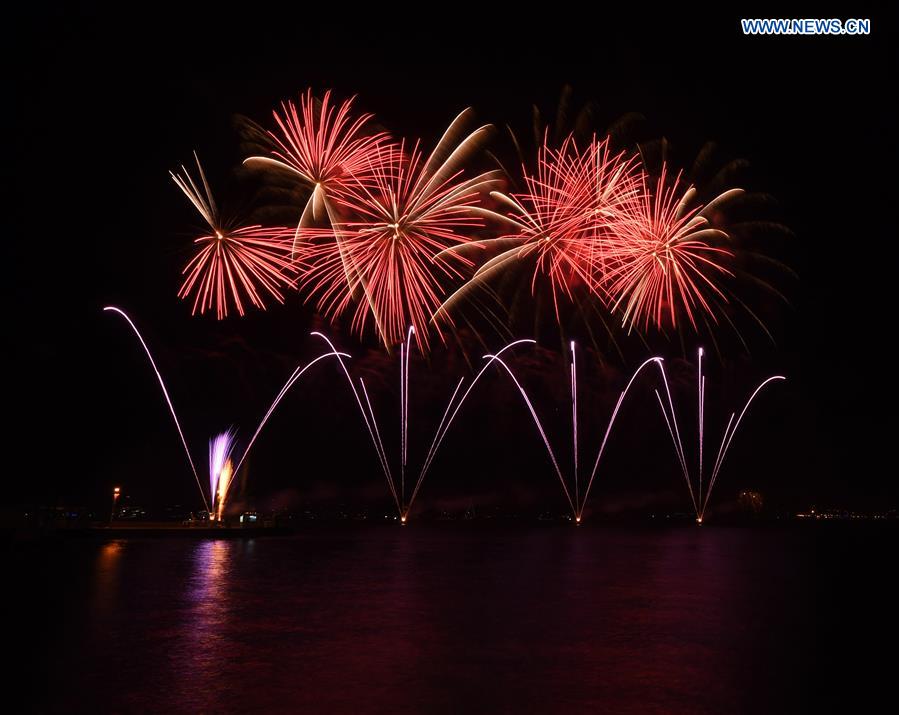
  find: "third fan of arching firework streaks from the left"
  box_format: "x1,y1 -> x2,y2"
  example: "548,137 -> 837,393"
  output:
484,341 -> 664,524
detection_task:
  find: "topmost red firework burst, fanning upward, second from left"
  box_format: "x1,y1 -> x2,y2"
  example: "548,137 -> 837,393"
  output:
246,89 -> 388,227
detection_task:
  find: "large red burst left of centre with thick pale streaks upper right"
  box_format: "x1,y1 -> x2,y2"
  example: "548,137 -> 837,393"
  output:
299,110 -> 497,351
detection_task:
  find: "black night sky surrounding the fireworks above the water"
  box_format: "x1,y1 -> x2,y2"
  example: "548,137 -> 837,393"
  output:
2,4 -> 899,510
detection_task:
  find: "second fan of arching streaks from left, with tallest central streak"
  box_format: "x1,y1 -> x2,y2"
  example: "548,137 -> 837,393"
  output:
313,327 -> 535,524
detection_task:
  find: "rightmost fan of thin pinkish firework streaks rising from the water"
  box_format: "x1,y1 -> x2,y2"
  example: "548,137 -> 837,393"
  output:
655,348 -> 787,524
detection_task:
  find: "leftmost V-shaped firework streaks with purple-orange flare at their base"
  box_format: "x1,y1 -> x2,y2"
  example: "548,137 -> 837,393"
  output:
103,305 -> 350,518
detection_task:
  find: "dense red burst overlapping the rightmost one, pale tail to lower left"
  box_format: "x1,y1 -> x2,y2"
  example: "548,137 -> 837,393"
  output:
438,137 -> 639,318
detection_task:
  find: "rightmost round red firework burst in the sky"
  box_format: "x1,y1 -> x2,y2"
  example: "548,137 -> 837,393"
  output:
603,165 -> 741,330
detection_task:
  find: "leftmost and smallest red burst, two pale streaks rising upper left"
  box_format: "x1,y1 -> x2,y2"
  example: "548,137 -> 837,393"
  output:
171,154 -> 294,320
